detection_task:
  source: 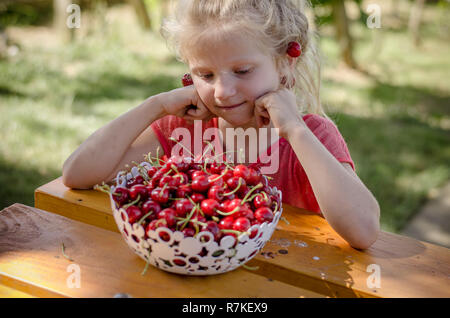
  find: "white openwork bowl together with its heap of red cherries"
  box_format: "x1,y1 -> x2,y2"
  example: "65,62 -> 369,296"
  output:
96,154 -> 282,275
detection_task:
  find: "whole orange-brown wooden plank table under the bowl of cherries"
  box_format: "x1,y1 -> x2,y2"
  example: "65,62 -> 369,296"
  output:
0,178 -> 450,298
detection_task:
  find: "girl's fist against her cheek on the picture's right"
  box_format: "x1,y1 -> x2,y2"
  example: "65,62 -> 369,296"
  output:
255,88 -> 307,138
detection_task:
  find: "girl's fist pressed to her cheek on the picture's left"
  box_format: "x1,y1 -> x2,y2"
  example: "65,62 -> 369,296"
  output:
159,85 -> 214,124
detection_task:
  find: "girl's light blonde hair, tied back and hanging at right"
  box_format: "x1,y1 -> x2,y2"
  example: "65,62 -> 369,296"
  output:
161,0 -> 328,118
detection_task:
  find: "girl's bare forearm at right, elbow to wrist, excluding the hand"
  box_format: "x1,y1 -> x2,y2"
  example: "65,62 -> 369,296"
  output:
286,125 -> 380,249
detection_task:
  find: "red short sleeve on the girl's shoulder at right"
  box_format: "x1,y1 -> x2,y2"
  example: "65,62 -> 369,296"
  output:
304,114 -> 355,170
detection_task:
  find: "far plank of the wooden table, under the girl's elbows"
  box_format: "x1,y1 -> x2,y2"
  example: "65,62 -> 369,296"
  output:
31,178 -> 450,297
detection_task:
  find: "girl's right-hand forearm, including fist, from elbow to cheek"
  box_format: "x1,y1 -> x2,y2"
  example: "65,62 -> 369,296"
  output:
255,88 -> 380,249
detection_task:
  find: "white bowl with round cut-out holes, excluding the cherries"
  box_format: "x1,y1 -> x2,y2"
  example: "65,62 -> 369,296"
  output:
110,162 -> 282,275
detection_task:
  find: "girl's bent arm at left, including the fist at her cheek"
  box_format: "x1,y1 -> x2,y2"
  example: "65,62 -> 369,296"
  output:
63,85 -> 213,189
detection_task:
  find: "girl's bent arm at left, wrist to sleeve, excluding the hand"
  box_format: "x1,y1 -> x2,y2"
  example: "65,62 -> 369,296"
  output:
62,95 -> 165,189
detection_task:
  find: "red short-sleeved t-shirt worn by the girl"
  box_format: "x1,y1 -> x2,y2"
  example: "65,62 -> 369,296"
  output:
151,114 -> 355,213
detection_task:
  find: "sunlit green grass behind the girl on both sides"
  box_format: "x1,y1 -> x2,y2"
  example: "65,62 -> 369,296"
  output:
0,2 -> 450,232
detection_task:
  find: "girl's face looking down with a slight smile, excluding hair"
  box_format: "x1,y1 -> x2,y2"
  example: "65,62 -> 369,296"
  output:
189,35 -> 280,127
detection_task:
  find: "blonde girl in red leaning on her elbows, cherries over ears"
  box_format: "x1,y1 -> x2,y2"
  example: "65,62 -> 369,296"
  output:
63,0 -> 380,249
